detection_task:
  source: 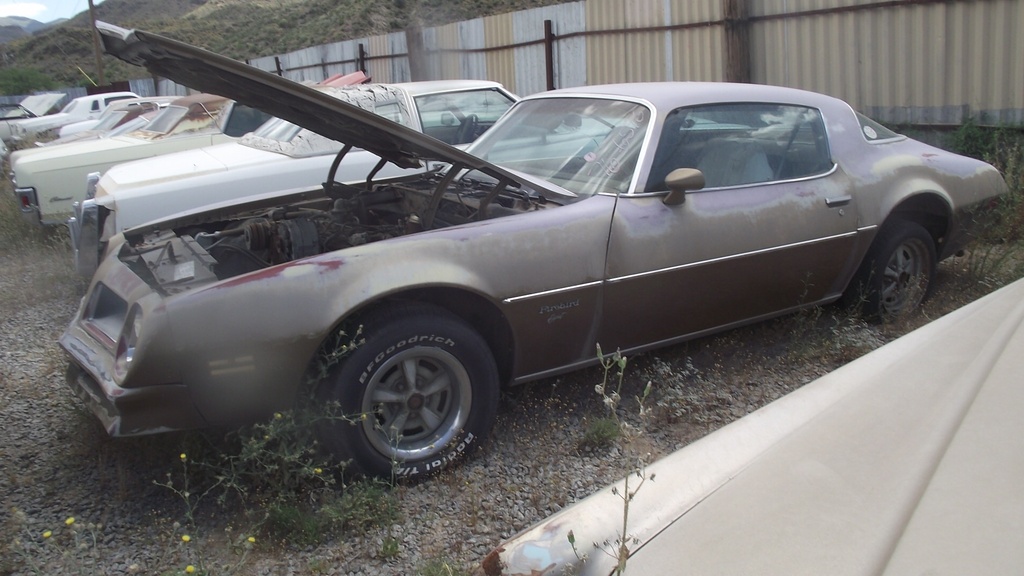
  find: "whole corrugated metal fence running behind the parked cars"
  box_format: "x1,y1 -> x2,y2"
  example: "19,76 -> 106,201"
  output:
149,0 -> 1024,125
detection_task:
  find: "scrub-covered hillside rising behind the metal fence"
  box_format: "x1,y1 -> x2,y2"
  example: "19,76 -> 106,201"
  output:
4,0 -> 558,85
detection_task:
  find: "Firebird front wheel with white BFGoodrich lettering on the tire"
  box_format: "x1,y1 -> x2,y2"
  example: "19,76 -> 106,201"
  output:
318,304 -> 499,478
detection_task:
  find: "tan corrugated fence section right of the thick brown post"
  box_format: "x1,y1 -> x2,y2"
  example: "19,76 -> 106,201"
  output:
751,0 -> 1024,124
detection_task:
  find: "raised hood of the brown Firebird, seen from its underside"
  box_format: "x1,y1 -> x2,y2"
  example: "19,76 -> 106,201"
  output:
96,22 -> 505,172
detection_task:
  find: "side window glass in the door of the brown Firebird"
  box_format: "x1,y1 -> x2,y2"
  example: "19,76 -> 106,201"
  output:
646,104 -> 831,192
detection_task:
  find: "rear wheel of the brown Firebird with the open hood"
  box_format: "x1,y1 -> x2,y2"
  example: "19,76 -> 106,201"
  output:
851,220 -> 936,321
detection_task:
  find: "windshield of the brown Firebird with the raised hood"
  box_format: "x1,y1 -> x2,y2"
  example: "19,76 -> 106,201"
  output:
469,97 -> 650,196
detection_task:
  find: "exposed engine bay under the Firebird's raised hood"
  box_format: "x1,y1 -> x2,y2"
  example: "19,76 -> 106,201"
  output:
119,167 -> 552,294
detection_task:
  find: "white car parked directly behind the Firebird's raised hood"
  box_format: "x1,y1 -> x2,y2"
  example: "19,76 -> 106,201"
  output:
69,80 -> 517,276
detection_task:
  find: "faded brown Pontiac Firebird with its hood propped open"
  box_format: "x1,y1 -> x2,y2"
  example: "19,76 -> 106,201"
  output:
60,25 -> 1006,476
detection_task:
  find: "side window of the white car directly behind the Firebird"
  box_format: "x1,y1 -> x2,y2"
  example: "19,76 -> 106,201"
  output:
416,88 -> 512,145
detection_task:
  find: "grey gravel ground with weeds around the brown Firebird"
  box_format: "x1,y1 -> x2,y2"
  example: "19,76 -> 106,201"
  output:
0,248 -> 983,575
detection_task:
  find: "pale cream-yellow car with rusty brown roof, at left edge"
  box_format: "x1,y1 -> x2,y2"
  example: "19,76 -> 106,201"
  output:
10,94 -> 269,224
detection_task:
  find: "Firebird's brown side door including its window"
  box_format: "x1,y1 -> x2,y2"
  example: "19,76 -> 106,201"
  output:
599,104 -> 857,351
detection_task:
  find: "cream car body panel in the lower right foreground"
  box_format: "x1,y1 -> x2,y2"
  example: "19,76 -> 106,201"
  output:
476,280 -> 1024,576
